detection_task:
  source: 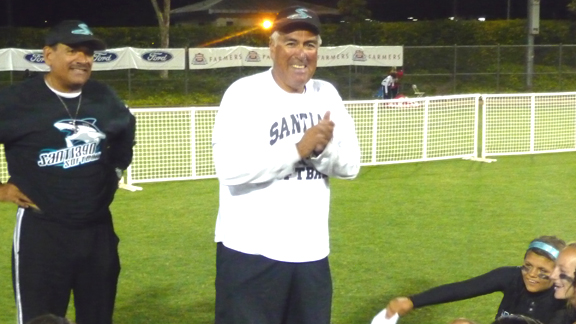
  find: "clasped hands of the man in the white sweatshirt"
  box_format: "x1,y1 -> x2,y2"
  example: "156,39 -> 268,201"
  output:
296,111 -> 334,159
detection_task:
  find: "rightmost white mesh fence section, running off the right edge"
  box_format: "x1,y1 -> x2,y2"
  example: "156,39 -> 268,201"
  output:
482,92 -> 576,157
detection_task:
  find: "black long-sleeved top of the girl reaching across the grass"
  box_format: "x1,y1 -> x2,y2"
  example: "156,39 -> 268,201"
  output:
410,267 -> 565,324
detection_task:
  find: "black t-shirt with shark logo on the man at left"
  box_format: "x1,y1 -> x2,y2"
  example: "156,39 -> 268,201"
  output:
0,76 -> 135,225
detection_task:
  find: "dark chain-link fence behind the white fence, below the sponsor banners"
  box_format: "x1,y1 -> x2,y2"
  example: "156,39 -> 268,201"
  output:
0,44 -> 576,107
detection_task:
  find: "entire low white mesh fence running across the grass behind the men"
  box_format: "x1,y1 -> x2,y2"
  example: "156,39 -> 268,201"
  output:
0,92 -> 576,184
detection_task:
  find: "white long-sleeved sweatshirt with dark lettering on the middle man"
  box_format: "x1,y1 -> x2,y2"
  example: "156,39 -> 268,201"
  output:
212,70 -> 360,262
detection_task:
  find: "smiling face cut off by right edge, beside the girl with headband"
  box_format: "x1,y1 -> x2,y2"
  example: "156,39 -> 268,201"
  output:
550,243 -> 576,324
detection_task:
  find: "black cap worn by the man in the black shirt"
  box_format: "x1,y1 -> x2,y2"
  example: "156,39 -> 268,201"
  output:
44,20 -> 106,51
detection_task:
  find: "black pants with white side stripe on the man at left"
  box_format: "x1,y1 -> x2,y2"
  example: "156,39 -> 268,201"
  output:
12,208 -> 120,324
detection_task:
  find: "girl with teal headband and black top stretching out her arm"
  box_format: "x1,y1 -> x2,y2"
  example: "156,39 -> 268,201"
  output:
386,236 -> 566,324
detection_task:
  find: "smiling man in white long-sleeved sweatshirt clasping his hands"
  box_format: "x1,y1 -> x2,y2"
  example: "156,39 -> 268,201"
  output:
212,7 -> 360,324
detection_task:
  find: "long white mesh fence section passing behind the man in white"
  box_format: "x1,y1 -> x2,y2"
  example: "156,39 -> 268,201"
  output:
127,94 -> 480,184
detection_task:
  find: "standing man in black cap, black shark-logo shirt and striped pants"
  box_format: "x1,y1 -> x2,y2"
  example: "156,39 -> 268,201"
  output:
0,21 -> 135,324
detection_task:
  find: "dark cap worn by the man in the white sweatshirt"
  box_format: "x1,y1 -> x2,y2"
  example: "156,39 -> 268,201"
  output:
272,6 -> 320,35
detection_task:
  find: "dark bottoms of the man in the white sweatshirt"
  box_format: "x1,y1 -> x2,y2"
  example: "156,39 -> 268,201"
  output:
215,243 -> 332,324
